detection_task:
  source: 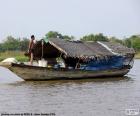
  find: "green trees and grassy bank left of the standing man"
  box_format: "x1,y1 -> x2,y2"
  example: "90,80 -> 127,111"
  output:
0,36 -> 29,62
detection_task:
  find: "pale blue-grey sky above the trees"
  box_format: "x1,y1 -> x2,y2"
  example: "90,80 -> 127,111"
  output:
0,0 -> 140,41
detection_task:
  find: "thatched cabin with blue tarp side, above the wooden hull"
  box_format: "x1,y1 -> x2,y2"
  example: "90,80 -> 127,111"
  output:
25,38 -> 135,70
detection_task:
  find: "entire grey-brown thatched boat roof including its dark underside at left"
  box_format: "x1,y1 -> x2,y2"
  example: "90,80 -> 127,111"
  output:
32,38 -> 135,58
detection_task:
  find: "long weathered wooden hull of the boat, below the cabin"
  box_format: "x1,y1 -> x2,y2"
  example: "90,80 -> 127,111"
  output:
1,63 -> 129,81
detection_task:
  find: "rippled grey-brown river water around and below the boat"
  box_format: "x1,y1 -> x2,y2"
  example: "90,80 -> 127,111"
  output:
0,60 -> 140,116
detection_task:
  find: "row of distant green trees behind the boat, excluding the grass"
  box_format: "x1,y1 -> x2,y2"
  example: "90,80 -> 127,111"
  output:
0,31 -> 140,52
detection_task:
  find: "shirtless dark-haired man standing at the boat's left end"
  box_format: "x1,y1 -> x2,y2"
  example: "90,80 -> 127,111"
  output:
28,35 -> 35,65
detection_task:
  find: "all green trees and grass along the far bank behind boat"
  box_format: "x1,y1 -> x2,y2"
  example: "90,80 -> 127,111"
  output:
0,31 -> 140,61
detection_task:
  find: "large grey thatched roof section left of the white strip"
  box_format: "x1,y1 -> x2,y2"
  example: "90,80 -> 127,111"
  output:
49,39 -> 112,57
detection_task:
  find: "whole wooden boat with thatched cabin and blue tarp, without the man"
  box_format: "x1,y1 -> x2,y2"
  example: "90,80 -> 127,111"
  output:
0,38 -> 135,80
